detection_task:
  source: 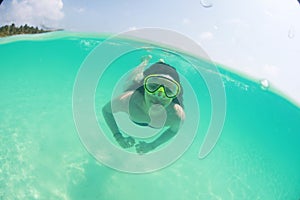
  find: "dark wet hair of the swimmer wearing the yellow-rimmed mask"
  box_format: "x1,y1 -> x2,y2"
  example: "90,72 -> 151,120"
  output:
126,62 -> 183,107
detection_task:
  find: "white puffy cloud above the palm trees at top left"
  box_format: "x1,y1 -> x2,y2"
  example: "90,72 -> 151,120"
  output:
1,0 -> 64,26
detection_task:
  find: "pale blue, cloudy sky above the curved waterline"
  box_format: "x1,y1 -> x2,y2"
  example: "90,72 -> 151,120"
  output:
0,0 -> 300,106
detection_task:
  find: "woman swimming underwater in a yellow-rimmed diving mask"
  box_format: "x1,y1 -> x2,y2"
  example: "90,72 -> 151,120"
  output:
102,56 -> 185,154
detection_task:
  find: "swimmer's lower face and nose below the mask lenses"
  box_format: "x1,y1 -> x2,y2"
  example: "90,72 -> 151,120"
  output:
145,87 -> 173,107
